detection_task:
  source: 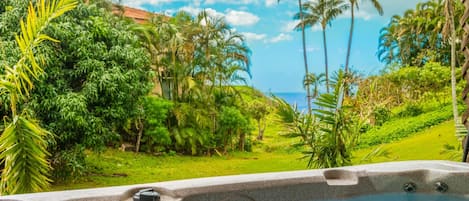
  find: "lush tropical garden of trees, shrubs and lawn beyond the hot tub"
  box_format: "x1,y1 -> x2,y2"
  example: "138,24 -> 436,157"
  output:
0,0 -> 462,194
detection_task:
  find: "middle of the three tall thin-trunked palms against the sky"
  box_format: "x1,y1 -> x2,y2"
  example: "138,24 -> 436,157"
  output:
295,0 -> 349,93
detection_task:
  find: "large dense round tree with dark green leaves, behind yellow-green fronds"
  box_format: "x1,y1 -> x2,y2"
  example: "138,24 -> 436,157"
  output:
0,0 -> 151,182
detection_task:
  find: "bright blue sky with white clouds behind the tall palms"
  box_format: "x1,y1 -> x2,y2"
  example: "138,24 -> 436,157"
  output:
122,0 -> 424,92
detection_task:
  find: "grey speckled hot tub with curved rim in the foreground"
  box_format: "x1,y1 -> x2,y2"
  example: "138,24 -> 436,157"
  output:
0,161 -> 469,201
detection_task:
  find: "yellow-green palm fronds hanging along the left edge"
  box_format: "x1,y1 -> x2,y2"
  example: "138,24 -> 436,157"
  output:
0,0 -> 77,194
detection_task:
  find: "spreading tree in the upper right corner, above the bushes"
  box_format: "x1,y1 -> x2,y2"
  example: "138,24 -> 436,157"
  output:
377,0 -> 464,66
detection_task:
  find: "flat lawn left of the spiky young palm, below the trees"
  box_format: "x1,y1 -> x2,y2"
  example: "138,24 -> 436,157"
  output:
52,115 -> 307,190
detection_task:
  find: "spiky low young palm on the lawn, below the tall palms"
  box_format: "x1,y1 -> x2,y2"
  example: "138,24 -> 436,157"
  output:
305,71 -> 358,168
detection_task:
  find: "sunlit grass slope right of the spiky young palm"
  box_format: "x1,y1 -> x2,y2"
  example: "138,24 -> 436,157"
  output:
354,121 -> 461,164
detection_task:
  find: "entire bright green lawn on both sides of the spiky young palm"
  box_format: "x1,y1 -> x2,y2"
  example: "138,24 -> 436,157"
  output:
52,119 -> 460,190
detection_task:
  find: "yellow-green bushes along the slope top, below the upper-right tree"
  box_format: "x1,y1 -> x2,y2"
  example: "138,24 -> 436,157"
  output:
354,62 -> 451,113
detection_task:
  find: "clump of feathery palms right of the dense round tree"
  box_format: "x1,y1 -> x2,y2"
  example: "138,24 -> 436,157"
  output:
131,11 -> 250,155
